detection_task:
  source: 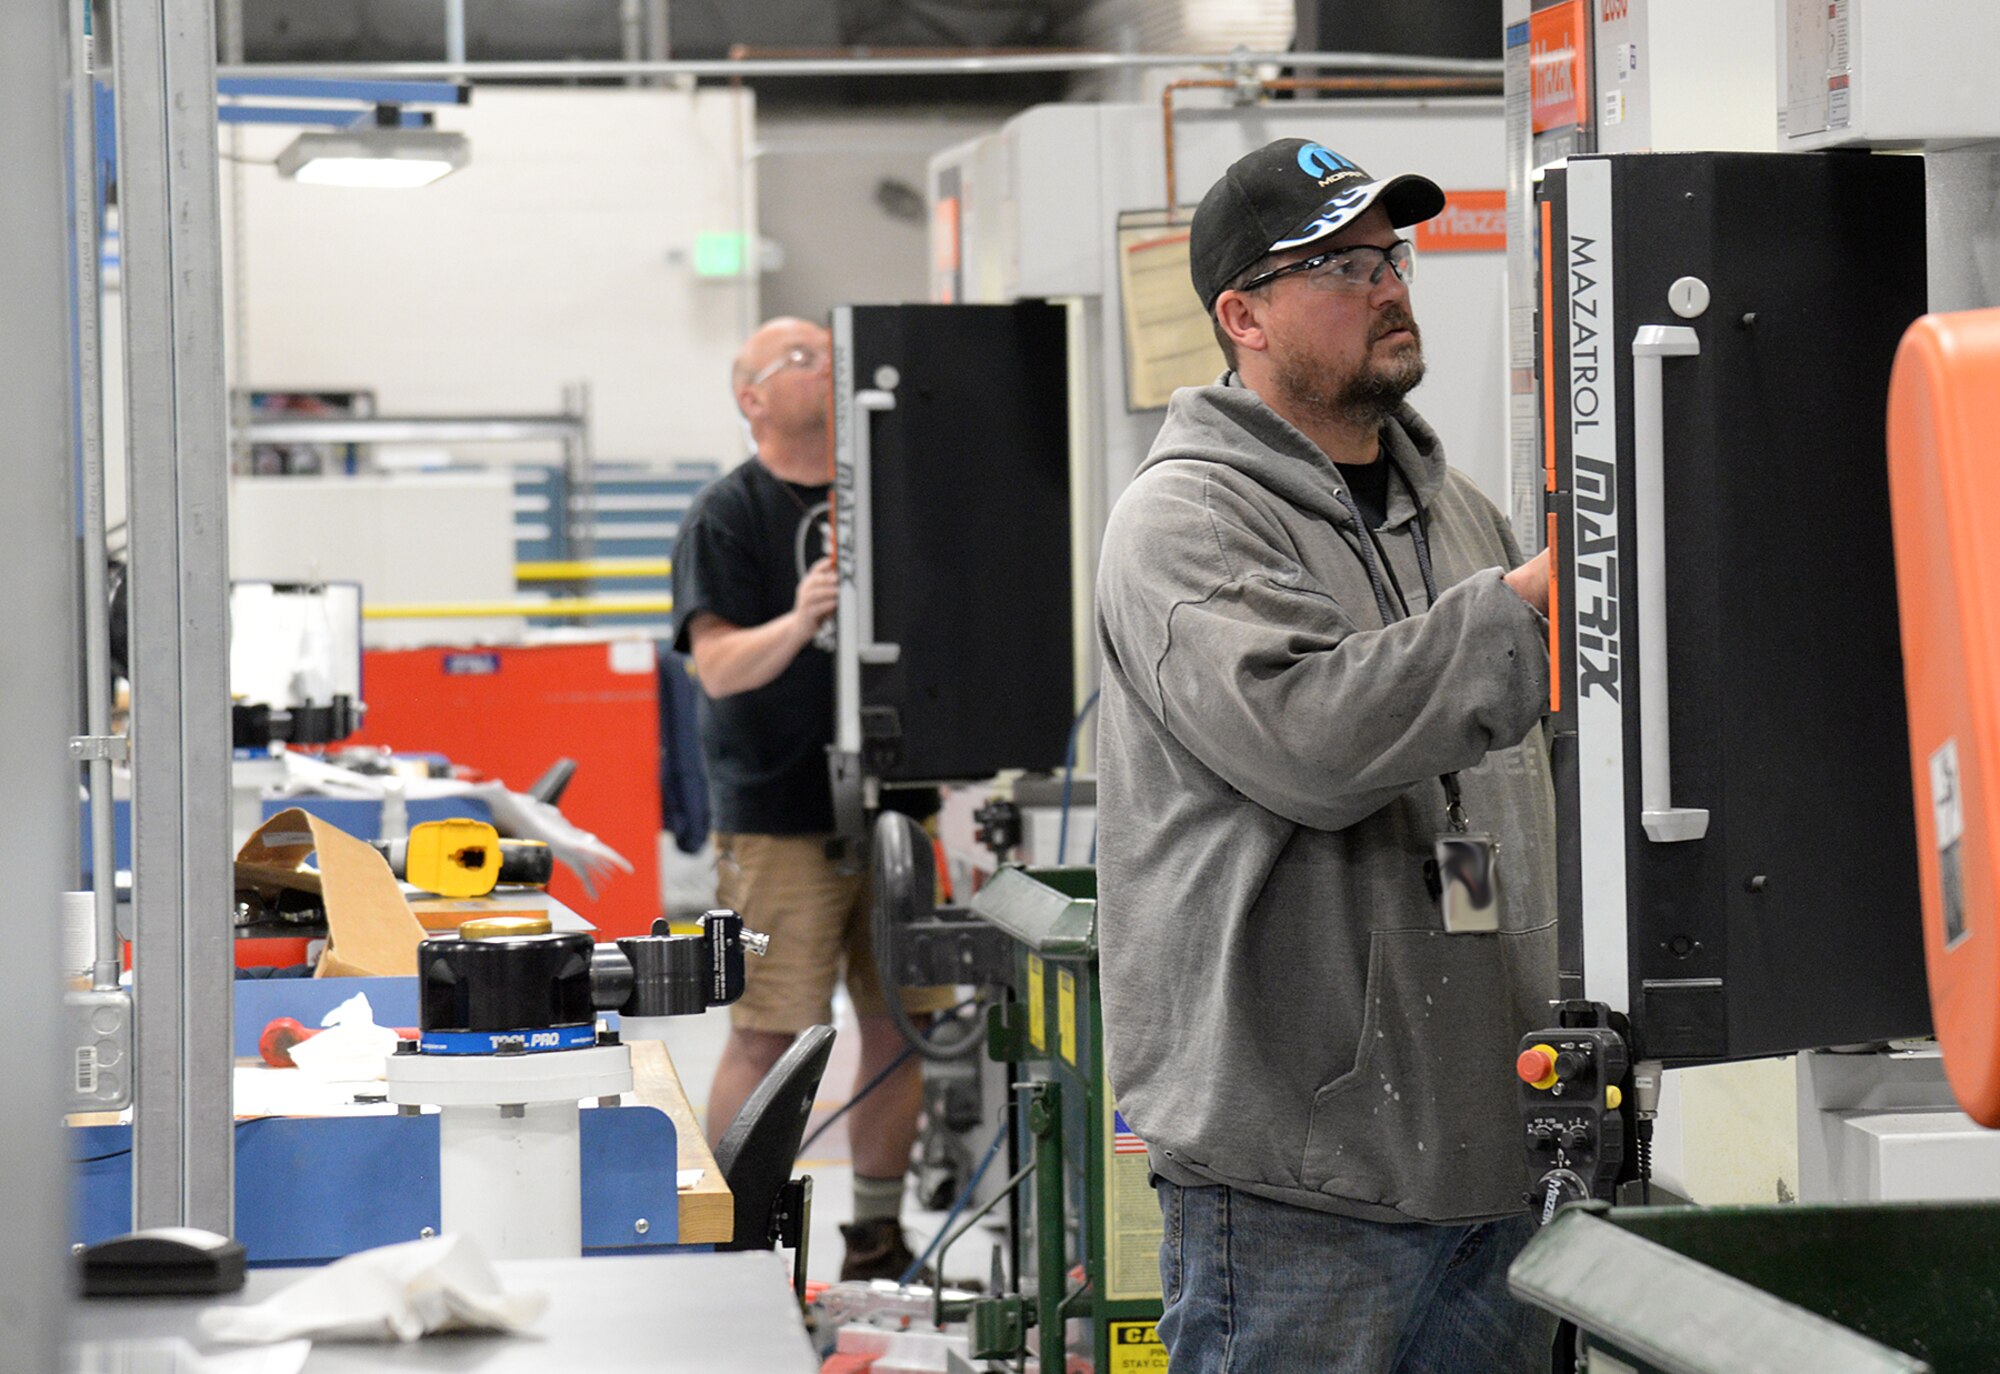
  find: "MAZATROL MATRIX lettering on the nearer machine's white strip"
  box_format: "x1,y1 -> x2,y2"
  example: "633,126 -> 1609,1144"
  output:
1570,234 -> 1622,702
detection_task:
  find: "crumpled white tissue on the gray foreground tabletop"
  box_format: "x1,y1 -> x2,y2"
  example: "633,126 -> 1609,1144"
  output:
202,1236 -> 548,1344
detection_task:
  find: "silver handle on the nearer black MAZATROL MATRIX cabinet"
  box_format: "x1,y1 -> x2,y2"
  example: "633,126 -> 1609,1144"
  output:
1632,324 -> 1708,844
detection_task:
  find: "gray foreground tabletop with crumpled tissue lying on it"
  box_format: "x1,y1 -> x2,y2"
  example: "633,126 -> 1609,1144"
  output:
70,1250 -> 820,1374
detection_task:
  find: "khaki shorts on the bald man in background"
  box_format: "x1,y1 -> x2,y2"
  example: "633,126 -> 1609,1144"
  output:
716,834 -> 958,1034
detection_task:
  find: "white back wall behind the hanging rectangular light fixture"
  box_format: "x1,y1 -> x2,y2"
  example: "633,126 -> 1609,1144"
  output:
224,88 -> 758,470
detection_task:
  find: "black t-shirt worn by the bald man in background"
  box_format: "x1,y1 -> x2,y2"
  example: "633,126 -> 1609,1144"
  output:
674,458 -> 834,834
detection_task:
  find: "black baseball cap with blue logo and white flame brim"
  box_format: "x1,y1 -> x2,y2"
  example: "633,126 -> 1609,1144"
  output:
1188,138 -> 1444,310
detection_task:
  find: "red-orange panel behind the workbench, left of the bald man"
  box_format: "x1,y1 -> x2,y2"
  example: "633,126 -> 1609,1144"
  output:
354,642 -> 660,940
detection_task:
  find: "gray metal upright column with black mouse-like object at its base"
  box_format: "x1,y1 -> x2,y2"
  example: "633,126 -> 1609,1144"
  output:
112,0 -> 234,1234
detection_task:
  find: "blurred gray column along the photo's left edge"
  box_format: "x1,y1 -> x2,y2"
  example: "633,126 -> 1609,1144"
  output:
0,4 -> 78,1374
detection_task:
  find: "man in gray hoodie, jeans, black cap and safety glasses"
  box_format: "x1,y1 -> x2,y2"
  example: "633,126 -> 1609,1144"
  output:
1098,138 -> 1556,1374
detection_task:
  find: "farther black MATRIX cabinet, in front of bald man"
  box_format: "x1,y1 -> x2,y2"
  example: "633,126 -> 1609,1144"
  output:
836,302 -> 1074,782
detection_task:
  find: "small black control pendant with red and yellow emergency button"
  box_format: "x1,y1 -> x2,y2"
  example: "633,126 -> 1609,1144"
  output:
1514,1016 -> 1630,1222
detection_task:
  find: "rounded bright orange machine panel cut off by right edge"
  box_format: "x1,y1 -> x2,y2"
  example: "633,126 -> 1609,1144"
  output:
1888,310 -> 2000,1126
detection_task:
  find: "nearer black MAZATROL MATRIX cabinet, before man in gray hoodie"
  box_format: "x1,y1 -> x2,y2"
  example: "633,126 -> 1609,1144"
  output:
1538,152 -> 1930,1064
